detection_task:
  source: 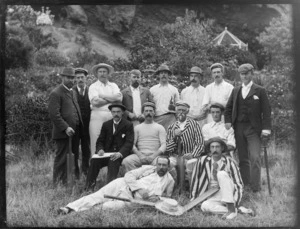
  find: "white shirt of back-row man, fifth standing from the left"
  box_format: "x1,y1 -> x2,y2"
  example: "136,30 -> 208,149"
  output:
150,83 -> 179,116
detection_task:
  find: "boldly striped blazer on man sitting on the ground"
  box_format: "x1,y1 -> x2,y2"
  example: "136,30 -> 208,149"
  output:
190,155 -> 244,206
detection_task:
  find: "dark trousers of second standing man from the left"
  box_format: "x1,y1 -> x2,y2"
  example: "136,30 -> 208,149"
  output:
73,119 -> 91,175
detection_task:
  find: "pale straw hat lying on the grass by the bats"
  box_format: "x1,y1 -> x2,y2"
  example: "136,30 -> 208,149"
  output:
155,198 -> 184,216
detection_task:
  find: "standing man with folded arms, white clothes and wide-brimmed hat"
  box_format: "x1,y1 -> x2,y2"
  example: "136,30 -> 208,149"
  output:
89,63 -> 122,155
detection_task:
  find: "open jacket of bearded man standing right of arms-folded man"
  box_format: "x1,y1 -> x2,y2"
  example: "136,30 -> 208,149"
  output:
121,86 -> 153,119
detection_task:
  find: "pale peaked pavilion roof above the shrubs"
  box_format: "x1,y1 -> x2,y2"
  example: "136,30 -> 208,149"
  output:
212,27 -> 248,51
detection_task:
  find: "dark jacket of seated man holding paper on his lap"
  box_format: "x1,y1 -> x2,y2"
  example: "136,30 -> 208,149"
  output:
96,118 -> 134,158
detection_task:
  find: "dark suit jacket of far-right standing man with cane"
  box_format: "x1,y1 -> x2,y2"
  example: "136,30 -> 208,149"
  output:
224,83 -> 271,132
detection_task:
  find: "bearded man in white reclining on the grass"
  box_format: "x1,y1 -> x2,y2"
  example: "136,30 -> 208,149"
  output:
59,156 -> 175,214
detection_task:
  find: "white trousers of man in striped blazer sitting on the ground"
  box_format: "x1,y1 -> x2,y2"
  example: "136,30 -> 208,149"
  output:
201,171 -> 235,214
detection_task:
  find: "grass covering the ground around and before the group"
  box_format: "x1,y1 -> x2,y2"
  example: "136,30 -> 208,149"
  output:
6,140 -> 297,227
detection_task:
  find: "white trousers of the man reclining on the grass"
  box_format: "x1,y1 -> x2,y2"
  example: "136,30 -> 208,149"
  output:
66,178 -> 132,212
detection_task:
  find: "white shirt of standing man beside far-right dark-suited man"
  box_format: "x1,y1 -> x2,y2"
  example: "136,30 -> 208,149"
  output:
202,80 -> 233,107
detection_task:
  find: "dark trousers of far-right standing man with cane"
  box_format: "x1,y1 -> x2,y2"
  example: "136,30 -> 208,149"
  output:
234,123 -> 261,191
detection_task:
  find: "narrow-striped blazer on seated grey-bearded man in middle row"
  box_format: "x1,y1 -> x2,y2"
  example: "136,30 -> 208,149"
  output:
166,118 -> 204,157
